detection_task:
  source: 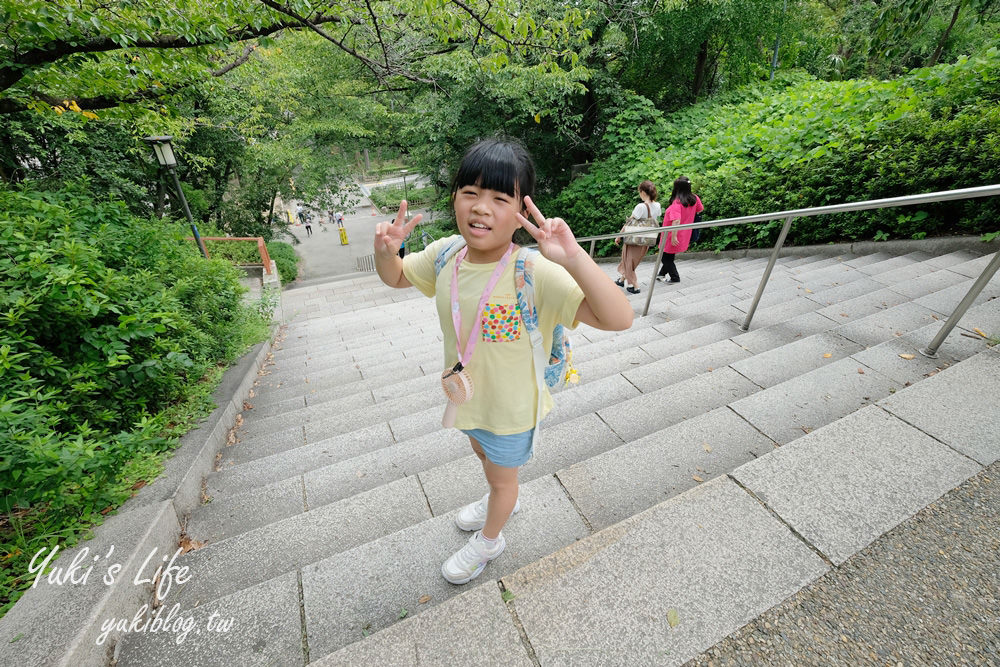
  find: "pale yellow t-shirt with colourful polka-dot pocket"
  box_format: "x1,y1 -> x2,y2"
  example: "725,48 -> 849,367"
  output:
403,237 -> 583,435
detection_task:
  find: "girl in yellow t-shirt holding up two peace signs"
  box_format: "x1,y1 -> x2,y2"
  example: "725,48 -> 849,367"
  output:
375,139 -> 633,584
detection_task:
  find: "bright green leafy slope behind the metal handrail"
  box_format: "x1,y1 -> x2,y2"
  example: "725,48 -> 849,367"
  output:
553,49 -> 1000,253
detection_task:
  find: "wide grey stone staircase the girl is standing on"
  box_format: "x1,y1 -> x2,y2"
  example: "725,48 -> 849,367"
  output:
116,251 -> 1000,667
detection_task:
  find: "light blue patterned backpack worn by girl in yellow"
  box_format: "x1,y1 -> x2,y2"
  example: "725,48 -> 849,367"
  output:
434,235 -> 580,396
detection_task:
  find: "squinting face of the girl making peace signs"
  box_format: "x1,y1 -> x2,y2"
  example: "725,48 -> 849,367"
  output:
455,185 -> 521,263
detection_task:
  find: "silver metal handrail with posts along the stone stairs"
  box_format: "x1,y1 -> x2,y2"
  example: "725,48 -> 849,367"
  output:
577,184 -> 1000,358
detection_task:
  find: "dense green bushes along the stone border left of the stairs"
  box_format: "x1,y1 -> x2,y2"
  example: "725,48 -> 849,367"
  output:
0,188 -> 269,613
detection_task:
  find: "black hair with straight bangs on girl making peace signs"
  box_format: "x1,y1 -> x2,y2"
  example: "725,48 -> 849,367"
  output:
451,139 -> 535,201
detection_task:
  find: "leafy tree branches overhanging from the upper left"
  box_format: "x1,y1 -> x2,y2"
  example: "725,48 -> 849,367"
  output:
0,0 -> 580,114
